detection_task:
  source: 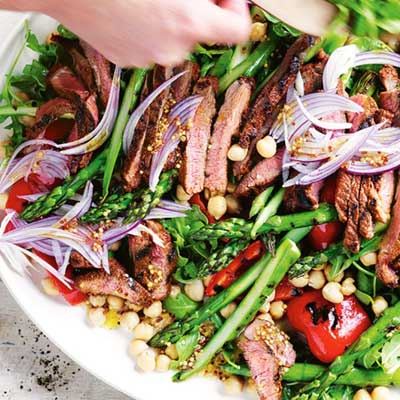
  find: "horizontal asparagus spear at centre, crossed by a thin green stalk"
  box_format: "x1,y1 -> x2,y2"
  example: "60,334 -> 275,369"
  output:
193,204 -> 337,241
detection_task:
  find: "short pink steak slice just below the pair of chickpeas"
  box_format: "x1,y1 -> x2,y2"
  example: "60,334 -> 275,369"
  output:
235,148 -> 284,197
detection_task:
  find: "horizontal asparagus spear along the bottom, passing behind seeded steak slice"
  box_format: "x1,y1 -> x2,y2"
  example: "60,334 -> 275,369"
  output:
222,363 -> 400,387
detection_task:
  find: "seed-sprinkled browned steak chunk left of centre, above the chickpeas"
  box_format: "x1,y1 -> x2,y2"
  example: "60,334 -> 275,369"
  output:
129,221 -> 176,300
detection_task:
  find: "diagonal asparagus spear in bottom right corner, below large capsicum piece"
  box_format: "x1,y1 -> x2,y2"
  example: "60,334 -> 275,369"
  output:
294,302 -> 400,400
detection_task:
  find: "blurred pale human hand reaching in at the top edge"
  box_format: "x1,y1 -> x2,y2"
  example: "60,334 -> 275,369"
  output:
18,0 -> 251,67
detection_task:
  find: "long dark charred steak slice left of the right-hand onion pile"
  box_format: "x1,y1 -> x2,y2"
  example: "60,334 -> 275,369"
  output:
234,35 -> 313,177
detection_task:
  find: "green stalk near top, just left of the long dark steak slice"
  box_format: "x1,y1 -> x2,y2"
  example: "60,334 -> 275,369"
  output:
219,36 -> 278,93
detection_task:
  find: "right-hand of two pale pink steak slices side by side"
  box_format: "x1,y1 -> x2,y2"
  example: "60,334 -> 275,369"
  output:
205,78 -> 254,195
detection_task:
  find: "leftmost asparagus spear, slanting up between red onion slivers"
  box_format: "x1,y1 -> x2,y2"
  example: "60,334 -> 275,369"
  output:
21,150 -> 107,221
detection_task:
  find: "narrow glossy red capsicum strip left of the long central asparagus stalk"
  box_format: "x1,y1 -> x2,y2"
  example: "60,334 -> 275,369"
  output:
205,240 -> 265,296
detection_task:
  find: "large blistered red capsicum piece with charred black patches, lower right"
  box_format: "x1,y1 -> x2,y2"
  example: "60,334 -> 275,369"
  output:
287,290 -> 371,363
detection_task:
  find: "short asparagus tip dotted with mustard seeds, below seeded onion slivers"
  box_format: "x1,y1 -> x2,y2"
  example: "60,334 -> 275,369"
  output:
125,169 -> 177,224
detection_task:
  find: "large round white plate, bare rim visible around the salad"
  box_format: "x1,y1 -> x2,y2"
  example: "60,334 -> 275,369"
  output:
0,11 -> 394,400
